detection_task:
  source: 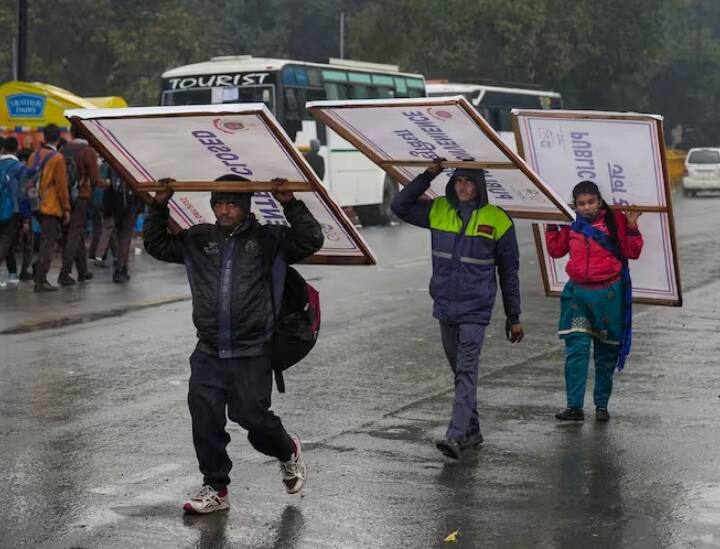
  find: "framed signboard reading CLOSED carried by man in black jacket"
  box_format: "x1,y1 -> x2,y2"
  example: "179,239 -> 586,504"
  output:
65,104 -> 375,264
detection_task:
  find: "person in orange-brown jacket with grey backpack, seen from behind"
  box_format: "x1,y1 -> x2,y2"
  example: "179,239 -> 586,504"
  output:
28,124 -> 71,292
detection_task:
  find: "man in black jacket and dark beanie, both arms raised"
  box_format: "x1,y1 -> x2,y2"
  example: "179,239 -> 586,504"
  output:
143,175 -> 323,513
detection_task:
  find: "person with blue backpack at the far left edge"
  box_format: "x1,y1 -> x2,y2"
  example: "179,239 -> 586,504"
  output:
0,137 -> 24,282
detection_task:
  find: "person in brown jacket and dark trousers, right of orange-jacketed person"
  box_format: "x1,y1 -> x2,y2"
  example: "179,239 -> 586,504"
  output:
58,126 -> 104,286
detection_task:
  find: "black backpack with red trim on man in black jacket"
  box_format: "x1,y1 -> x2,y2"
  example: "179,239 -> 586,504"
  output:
260,227 -> 320,393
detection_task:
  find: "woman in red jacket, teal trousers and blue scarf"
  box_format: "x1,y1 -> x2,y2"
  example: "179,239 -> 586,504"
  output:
545,181 -> 643,421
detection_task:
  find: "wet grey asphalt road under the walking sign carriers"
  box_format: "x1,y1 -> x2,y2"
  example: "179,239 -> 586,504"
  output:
0,191 -> 720,549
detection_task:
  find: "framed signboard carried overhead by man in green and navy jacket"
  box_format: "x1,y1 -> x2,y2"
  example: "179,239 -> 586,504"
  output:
307,97 -> 573,221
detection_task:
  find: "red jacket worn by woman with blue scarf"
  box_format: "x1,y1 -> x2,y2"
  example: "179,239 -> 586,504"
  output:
545,210 -> 643,285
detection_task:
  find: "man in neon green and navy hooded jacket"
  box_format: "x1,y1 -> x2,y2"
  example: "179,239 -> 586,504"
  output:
392,159 -> 523,459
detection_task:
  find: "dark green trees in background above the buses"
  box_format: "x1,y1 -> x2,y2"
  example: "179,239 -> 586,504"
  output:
0,0 -> 720,142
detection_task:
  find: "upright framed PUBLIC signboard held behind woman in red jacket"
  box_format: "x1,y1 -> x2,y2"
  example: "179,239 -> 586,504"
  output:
513,110 -> 682,306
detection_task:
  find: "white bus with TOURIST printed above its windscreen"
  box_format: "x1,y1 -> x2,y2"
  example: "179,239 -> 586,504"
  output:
160,55 -> 426,225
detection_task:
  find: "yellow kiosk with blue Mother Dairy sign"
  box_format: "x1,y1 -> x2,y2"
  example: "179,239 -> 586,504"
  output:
0,80 -> 127,147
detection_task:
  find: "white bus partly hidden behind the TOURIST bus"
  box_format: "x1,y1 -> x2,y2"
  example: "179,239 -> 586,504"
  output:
426,80 -> 562,150
